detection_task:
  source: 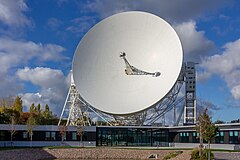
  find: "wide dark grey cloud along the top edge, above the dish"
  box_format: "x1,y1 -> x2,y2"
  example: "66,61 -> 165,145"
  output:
86,0 -> 231,22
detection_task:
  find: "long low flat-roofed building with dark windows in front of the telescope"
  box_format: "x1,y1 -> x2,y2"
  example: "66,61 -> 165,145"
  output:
0,123 -> 240,150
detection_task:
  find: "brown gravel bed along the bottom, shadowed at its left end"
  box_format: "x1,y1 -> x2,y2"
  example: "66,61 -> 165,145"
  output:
0,148 -> 190,160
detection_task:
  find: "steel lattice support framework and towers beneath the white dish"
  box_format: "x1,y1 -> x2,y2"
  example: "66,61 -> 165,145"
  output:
58,62 -> 196,126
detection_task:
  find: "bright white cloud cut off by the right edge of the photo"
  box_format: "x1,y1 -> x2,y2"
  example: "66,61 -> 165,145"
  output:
200,39 -> 240,100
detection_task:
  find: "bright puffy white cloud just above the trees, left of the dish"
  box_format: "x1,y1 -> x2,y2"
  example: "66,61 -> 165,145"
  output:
16,67 -> 69,114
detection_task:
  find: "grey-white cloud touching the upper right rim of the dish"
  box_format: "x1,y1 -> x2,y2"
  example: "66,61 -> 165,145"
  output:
174,21 -> 215,62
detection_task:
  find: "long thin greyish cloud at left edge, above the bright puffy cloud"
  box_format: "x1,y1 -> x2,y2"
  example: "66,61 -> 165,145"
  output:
0,37 -> 66,72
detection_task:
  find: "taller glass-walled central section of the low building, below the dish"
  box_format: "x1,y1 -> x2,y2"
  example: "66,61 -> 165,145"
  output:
97,127 -> 168,146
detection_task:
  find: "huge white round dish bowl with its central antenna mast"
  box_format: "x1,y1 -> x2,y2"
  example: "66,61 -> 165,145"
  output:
73,11 -> 183,115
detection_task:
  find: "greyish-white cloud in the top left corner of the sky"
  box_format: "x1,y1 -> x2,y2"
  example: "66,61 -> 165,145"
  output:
0,0 -> 31,27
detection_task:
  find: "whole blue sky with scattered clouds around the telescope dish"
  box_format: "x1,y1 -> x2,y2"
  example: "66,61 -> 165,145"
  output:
0,0 -> 240,121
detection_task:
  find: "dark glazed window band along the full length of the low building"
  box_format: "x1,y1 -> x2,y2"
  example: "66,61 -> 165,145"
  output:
0,125 -> 240,147
